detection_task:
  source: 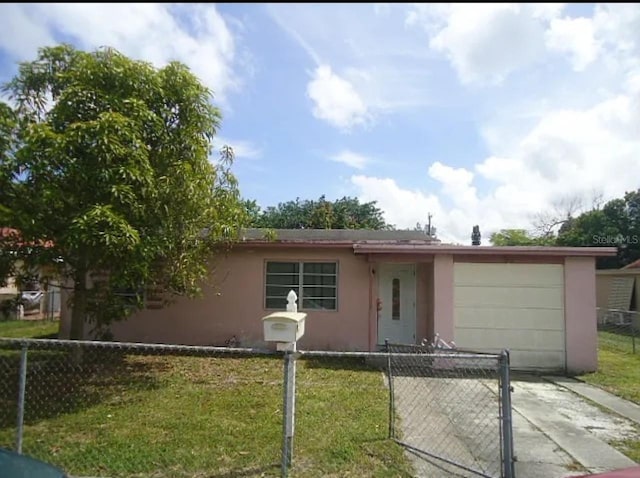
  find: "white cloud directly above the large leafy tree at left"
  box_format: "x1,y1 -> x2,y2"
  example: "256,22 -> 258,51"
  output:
0,3 -> 240,100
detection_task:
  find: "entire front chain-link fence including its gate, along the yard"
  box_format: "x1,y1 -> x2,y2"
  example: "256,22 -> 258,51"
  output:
0,338 -> 513,478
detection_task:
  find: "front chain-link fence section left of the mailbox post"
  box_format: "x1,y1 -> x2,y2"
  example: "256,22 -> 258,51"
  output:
0,339 -> 282,478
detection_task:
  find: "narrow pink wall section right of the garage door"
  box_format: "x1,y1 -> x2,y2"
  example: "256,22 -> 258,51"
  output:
564,257 -> 598,373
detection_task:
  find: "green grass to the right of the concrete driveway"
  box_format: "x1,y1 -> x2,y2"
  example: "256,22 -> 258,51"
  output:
579,332 -> 640,463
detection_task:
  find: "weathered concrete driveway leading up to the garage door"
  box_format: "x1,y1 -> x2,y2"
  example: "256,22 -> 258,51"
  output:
394,376 -> 640,478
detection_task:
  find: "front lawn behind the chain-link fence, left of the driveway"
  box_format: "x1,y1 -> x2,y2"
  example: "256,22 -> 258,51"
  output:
0,349 -> 412,478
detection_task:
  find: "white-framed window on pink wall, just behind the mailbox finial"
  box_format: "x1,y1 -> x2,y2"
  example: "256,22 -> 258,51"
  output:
265,261 -> 338,310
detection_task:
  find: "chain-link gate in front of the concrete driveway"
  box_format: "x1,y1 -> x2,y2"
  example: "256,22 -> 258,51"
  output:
386,343 -> 514,478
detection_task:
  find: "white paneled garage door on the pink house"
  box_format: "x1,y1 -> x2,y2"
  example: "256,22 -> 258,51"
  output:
454,263 -> 565,369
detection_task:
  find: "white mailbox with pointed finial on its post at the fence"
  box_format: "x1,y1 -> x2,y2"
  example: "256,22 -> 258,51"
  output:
262,290 -> 307,477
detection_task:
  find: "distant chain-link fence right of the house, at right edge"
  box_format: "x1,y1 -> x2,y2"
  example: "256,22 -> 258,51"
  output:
597,307 -> 640,354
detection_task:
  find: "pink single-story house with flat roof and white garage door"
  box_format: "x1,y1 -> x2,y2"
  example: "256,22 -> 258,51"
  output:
61,230 -> 615,372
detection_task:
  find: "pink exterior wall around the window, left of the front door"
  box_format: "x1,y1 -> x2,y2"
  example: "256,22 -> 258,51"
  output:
104,248 -> 370,350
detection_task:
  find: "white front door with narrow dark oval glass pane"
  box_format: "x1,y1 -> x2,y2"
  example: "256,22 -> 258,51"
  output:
378,264 -> 416,344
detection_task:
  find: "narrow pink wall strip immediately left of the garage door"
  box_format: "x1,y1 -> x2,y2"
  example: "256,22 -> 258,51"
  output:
433,254 -> 454,342
